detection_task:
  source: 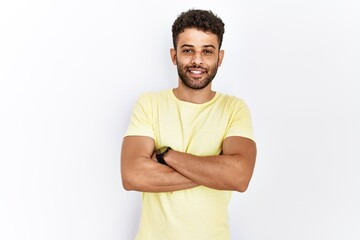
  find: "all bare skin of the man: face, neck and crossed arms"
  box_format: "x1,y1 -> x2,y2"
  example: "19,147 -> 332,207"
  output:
121,28 -> 256,192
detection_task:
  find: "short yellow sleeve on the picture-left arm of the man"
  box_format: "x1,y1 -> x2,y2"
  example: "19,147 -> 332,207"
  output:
125,94 -> 155,138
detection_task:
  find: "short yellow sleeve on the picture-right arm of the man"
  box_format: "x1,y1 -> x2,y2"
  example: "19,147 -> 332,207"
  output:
225,99 -> 255,141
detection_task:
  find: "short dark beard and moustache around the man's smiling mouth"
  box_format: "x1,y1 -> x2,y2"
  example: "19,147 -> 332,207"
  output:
177,59 -> 218,90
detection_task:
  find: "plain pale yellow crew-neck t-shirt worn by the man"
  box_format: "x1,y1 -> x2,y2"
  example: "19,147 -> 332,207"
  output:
125,90 -> 253,240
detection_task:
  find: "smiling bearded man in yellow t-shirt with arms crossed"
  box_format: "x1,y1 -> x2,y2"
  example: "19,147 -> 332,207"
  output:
121,10 -> 256,240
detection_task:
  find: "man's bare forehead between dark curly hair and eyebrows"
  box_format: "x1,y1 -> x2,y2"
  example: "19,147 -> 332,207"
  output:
177,28 -> 219,48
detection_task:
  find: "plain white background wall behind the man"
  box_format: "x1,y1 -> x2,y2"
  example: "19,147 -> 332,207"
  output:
0,0 -> 360,240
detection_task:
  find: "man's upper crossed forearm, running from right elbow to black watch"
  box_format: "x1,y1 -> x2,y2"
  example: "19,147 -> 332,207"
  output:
166,151 -> 253,192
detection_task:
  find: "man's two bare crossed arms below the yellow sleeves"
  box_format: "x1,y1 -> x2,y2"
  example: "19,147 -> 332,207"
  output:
121,136 -> 256,192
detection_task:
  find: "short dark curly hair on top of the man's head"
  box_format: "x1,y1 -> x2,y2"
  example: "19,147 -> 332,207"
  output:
172,9 -> 225,49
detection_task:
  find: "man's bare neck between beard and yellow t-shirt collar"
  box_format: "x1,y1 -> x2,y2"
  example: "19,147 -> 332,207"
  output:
173,80 -> 216,104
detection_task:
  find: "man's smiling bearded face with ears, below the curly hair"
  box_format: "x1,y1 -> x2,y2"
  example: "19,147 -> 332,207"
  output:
171,28 -> 224,89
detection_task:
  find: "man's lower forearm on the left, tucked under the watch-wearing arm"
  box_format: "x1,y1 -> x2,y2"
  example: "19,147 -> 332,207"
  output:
122,157 -> 198,192
